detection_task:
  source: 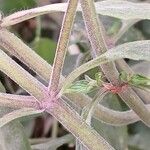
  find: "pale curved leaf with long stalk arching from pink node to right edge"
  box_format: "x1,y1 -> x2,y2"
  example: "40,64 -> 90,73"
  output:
61,40 -> 150,93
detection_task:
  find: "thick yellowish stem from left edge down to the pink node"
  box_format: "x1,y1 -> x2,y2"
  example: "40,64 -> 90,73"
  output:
0,50 -> 47,101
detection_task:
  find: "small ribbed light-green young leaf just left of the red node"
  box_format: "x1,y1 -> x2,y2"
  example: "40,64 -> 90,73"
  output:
64,80 -> 97,93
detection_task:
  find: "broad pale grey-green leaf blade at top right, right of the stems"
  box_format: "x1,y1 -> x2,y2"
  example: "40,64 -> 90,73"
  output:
95,0 -> 150,20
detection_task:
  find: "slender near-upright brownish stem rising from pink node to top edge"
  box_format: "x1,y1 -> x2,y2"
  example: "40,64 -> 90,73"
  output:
48,0 -> 78,93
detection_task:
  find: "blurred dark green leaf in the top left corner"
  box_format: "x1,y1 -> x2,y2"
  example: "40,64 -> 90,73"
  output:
0,0 -> 36,13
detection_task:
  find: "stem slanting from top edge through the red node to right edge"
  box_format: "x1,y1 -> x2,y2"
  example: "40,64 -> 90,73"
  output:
81,0 -> 150,126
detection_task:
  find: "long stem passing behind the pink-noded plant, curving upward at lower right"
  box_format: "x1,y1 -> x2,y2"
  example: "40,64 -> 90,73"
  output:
0,29 -> 149,125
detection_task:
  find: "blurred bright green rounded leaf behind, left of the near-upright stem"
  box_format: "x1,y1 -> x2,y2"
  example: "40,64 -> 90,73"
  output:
31,38 -> 56,64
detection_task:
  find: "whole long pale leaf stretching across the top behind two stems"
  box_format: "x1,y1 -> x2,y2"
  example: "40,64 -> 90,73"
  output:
1,0 -> 150,27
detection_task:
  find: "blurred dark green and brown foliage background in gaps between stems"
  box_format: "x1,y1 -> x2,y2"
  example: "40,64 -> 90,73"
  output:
0,0 -> 150,150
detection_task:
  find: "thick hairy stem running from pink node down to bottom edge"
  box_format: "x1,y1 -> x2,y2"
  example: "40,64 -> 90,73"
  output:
47,100 -> 114,150
